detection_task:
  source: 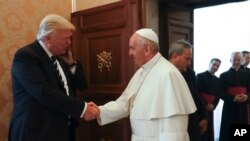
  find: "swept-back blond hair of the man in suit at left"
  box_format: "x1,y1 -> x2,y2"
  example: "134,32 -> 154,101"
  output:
36,14 -> 75,40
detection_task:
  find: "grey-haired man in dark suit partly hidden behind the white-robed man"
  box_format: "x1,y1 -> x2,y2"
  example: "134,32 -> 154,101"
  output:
168,40 -> 208,141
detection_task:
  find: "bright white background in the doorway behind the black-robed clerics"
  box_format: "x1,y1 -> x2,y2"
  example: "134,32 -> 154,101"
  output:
194,1 -> 250,139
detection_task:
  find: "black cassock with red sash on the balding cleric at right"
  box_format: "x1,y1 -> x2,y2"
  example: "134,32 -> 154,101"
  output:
219,68 -> 250,141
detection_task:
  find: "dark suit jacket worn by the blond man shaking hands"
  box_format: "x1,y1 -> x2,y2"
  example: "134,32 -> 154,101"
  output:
9,41 -> 86,141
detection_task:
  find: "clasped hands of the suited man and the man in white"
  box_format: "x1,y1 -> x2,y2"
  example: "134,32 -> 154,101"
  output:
83,102 -> 100,121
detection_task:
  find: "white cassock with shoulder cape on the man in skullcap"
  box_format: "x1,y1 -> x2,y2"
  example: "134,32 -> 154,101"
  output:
98,53 -> 196,141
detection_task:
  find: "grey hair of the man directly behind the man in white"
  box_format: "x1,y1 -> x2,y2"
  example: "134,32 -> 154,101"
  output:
168,40 -> 192,57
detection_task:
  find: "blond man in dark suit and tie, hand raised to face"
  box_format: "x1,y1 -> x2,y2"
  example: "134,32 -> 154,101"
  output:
9,14 -> 99,141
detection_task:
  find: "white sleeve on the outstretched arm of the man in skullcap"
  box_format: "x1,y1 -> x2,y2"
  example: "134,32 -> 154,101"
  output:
97,90 -> 129,125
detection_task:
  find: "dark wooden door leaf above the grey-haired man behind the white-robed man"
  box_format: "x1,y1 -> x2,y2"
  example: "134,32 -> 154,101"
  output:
159,3 -> 193,58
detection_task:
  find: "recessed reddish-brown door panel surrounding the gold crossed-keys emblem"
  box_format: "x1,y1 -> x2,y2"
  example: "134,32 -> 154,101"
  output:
82,28 -> 127,92
